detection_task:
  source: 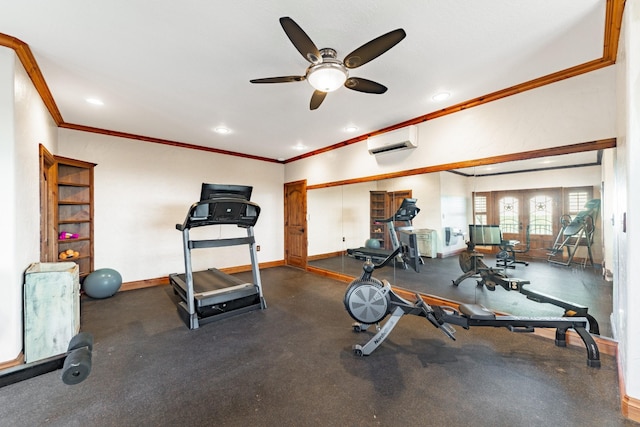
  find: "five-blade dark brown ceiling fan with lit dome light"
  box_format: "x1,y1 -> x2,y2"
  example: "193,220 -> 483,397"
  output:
250,16 -> 407,110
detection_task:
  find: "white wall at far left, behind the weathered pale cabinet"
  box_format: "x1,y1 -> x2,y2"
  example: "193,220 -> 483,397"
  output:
0,47 -> 57,363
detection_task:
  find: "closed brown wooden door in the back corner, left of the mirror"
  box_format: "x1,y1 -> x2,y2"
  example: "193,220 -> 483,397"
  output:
284,180 -> 307,268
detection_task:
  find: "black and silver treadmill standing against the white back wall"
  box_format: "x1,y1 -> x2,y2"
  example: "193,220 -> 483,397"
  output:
169,183 -> 267,329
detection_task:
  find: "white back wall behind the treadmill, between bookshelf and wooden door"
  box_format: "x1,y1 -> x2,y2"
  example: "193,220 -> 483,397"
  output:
58,129 -> 284,282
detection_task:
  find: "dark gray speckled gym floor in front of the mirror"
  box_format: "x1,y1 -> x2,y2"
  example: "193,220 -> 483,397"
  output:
0,267 -> 636,427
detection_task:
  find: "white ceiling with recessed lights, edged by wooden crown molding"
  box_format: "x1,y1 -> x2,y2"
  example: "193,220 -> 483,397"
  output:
0,0 -> 606,159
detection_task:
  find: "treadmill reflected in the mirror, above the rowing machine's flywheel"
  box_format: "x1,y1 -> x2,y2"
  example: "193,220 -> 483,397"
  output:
347,198 -> 423,268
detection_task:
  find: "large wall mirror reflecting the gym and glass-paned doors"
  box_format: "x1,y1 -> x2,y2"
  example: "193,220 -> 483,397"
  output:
307,148 -> 615,336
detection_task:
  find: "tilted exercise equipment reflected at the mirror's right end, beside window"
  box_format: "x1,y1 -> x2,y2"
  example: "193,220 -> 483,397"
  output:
547,199 -> 600,267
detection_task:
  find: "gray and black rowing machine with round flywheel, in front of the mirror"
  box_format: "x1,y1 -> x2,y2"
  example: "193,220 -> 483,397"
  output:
344,246 -> 600,368
